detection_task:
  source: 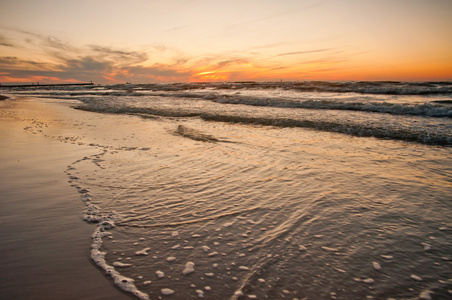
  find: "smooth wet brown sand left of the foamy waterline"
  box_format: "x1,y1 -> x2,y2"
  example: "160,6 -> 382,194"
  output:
0,100 -> 133,299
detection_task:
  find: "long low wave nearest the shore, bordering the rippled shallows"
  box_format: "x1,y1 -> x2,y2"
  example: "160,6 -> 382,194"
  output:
76,98 -> 452,146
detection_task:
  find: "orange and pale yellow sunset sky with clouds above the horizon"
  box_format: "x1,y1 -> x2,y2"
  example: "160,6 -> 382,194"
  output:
0,0 -> 452,83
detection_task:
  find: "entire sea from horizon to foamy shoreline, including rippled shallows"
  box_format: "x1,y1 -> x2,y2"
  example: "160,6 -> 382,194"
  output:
3,81 -> 452,300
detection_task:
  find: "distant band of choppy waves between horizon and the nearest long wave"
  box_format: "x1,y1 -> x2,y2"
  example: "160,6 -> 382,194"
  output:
6,81 -> 452,118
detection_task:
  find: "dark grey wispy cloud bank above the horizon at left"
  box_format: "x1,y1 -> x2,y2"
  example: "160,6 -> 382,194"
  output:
0,30 -> 190,82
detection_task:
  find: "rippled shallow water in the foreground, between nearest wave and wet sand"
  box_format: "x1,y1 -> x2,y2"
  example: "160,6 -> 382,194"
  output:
64,119 -> 452,299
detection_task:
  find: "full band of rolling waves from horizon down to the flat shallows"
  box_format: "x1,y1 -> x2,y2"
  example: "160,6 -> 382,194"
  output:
4,81 -> 452,146
